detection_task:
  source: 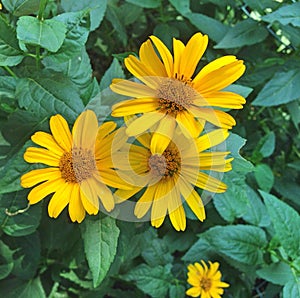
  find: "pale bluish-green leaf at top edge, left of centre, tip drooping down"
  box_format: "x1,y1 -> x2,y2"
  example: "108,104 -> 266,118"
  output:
61,0 -> 107,31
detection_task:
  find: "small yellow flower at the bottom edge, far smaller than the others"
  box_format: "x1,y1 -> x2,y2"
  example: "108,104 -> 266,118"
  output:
186,260 -> 229,298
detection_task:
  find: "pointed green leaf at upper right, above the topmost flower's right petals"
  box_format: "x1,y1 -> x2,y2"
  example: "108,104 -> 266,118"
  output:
214,19 -> 268,49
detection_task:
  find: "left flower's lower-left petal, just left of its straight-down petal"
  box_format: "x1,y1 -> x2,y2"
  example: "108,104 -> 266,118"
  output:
48,183 -> 71,218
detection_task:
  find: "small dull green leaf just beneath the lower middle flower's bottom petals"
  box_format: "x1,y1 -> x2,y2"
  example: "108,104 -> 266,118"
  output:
142,239 -> 173,267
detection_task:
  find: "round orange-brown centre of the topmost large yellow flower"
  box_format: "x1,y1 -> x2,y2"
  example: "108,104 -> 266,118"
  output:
156,78 -> 196,116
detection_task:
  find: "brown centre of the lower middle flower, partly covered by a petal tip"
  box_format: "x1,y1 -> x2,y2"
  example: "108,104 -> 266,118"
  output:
148,146 -> 181,178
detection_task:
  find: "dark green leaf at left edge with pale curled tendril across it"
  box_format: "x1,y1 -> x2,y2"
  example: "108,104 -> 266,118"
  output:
0,191 -> 42,237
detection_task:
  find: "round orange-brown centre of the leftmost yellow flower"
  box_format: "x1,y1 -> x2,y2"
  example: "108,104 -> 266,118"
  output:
59,147 -> 96,183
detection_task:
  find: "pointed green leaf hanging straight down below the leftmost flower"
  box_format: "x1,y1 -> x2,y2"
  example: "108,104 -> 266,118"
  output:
81,217 -> 120,287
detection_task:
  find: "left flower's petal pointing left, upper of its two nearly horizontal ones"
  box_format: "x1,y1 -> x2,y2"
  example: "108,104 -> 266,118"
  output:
24,147 -> 59,167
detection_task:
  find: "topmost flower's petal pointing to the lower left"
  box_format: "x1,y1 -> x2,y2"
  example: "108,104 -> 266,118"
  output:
126,112 -> 165,136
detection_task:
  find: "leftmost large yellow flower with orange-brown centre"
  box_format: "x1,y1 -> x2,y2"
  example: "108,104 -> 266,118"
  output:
21,110 -> 126,223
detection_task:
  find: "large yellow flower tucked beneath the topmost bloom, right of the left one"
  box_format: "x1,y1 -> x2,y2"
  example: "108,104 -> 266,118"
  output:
113,124 -> 232,231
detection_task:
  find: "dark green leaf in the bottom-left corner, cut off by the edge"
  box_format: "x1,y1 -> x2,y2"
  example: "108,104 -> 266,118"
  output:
0,277 -> 47,298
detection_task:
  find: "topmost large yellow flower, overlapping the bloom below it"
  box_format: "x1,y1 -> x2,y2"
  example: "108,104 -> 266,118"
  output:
110,33 -> 245,154
